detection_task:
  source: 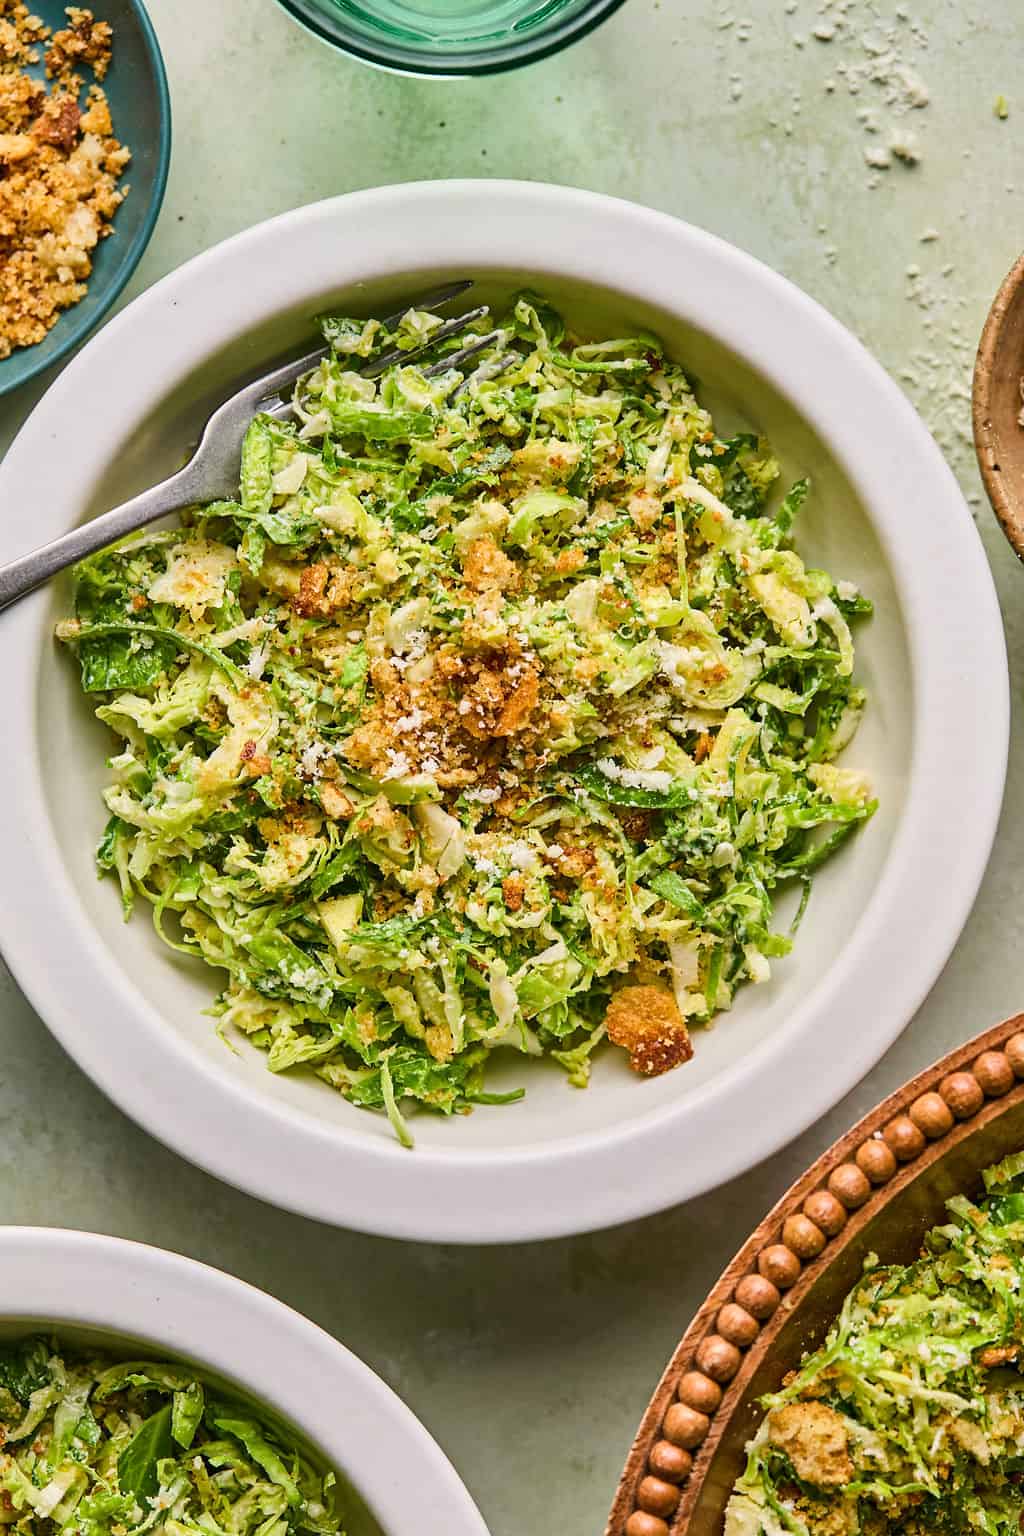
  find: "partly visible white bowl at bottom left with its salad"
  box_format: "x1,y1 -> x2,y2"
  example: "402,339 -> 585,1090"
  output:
0,1227 -> 487,1536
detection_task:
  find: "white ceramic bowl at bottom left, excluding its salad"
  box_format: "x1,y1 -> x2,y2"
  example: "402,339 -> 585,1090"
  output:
0,1227 -> 487,1536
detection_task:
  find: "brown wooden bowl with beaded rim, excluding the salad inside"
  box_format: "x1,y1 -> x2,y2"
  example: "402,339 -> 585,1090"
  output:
605,1014 -> 1024,1536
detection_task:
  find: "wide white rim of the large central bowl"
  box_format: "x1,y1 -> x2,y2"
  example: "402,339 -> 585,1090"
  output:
0,181 -> 1009,1243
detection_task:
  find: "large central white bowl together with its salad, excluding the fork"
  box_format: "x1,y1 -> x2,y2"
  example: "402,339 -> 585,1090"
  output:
0,183 -> 1007,1241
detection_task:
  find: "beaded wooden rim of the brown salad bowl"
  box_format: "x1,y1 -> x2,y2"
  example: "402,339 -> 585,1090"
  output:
605,1014 -> 1024,1536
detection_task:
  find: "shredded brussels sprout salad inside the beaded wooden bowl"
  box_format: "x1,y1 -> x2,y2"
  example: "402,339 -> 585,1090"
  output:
725,1152 -> 1024,1536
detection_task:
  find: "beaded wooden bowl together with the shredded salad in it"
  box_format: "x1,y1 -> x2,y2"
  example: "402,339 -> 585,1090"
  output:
608,1015 -> 1024,1536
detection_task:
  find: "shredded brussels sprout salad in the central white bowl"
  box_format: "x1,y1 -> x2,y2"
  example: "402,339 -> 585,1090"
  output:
58,298 -> 875,1141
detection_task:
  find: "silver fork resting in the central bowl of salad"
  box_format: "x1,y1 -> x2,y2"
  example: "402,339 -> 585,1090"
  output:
0,281 -> 507,610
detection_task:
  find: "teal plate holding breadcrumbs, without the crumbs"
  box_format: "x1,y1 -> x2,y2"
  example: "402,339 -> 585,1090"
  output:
0,0 -> 170,395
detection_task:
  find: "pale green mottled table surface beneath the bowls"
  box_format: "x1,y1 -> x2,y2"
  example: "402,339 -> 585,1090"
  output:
0,0 -> 1024,1536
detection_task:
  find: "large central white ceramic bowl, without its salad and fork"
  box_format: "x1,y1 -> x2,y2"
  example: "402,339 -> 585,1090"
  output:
0,181 -> 1009,1241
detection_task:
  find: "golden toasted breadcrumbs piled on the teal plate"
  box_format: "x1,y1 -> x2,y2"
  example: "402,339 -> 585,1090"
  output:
0,0 -> 130,358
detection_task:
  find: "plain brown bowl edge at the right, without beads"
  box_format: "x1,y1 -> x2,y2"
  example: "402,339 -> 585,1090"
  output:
972,248 -> 1024,561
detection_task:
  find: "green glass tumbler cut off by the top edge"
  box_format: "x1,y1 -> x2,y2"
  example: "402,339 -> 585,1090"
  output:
271,0 -> 623,80
